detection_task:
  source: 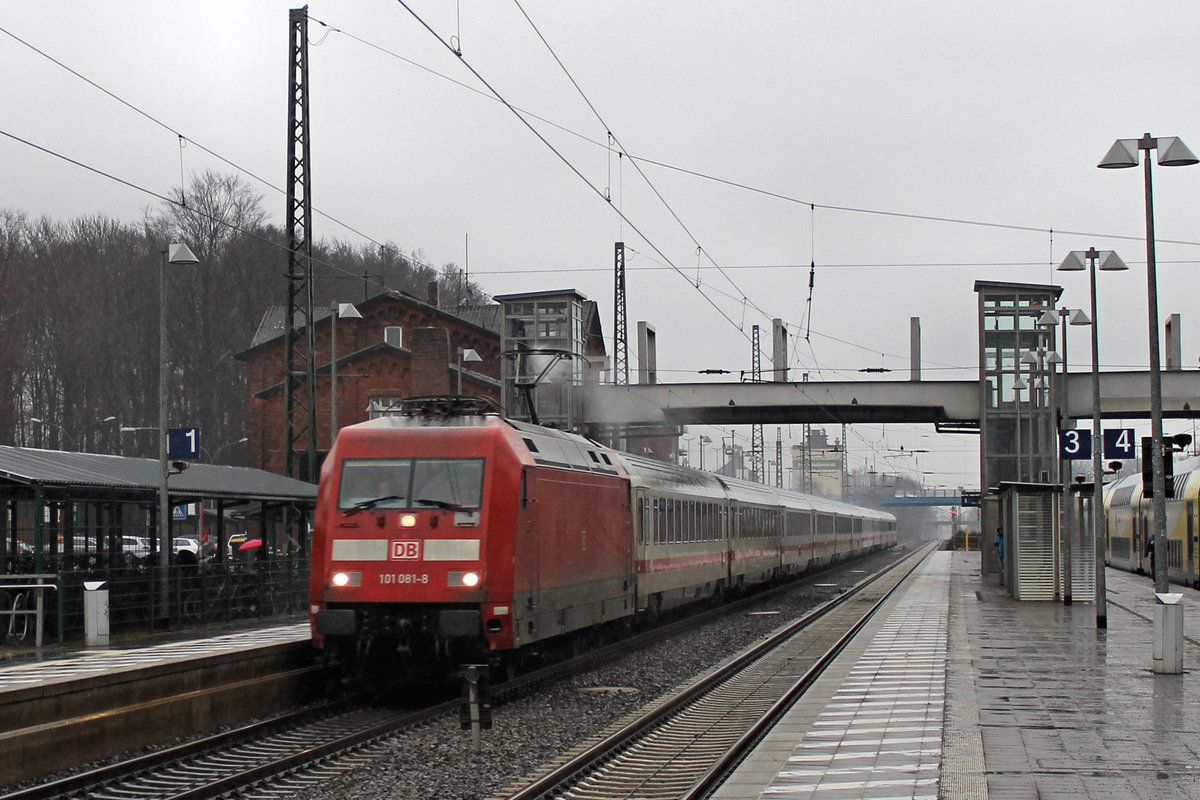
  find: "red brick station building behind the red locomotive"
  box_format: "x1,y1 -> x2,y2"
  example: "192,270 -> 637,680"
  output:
236,284 -> 502,474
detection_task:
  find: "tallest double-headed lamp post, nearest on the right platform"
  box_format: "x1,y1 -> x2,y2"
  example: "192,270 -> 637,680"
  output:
1098,133 -> 1200,673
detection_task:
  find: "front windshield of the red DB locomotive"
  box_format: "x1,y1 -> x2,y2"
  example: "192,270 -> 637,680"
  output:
337,458 -> 484,509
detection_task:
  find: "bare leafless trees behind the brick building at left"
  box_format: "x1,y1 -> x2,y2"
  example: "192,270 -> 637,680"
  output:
0,172 -> 487,464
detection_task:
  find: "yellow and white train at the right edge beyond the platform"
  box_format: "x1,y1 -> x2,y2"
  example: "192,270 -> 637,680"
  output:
1104,458 -> 1200,589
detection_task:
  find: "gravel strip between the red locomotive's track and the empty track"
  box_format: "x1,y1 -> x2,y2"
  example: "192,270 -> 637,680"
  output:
289,552 -> 901,800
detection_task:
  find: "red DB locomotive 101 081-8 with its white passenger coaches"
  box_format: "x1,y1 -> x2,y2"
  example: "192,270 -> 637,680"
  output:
310,397 -> 896,680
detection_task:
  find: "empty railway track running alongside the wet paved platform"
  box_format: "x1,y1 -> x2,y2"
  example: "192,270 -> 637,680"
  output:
492,547 -> 931,800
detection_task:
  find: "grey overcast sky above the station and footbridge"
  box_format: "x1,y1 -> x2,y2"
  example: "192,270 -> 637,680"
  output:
0,0 -> 1200,494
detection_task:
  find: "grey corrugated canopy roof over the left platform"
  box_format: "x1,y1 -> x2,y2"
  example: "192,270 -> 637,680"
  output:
0,445 -> 317,501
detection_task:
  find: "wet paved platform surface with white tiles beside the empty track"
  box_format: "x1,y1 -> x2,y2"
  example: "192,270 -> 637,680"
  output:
715,552 -> 1200,800
